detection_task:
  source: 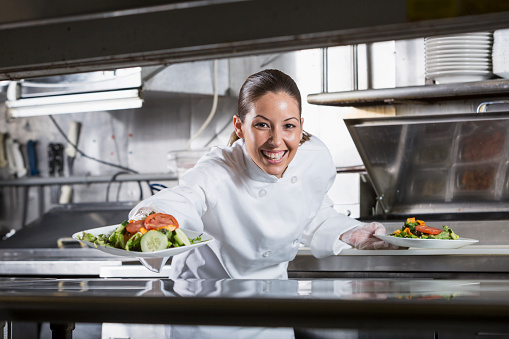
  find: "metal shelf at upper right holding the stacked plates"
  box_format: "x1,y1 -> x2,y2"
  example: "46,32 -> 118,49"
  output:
307,79 -> 509,106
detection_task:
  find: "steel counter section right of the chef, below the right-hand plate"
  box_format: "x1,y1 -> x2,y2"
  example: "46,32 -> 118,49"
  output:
288,245 -> 509,279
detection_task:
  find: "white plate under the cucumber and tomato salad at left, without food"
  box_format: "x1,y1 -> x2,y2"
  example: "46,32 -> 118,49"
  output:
72,224 -> 214,258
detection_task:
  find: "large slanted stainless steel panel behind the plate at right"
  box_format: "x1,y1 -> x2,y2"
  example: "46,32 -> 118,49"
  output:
345,112 -> 509,217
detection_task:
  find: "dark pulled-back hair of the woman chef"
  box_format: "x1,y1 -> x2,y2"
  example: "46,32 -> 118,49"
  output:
228,69 -> 311,145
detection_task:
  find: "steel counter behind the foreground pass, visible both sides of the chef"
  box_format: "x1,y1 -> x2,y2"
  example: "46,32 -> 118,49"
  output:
0,245 -> 509,279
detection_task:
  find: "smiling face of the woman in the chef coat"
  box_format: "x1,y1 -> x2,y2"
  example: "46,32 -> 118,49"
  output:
233,92 -> 304,178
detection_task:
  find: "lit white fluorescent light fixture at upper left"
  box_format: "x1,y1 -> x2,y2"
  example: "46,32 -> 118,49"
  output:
5,86 -> 143,117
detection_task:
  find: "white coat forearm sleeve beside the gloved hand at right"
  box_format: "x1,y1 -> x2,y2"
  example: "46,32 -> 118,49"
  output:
301,195 -> 362,258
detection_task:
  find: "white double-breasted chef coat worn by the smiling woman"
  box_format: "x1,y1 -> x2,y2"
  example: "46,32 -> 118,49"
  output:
130,136 -> 362,279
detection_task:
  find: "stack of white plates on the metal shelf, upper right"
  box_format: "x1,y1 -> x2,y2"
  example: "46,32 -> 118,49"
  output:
424,32 -> 493,84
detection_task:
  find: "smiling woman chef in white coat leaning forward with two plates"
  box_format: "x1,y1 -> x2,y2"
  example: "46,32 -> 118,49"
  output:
129,70 -> 394,279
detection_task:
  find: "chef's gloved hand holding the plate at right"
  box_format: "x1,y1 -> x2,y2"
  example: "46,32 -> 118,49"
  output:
340,222 -> 400,250
